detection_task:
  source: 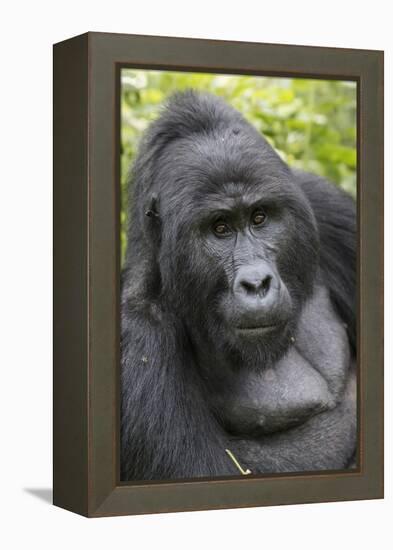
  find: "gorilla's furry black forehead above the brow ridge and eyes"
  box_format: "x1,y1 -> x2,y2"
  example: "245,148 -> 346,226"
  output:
157,132 -> 291,204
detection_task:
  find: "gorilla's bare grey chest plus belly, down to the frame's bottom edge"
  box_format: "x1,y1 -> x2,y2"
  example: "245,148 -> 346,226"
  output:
201,287 -> 356,472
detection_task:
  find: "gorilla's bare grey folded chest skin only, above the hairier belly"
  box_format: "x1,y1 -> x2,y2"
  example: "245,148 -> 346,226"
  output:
213,287 -> 351,437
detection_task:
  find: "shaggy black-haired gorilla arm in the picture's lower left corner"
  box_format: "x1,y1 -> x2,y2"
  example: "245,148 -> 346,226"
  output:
121,301 -> 238,480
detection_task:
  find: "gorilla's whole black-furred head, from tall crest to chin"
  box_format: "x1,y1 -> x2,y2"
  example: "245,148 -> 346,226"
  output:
129,91 -> 318,364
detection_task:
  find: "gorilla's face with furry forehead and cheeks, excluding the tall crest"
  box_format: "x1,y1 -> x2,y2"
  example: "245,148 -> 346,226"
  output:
153,132 -> 318,358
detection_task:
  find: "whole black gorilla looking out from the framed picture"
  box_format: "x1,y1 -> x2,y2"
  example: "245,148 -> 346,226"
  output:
120,90 -> 357,481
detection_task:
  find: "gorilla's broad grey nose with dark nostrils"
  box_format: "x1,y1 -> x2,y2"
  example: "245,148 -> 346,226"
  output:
234,262 -> 277,303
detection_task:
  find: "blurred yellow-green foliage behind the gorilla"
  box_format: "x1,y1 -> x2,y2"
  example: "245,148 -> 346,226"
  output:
121,69 -> 356,257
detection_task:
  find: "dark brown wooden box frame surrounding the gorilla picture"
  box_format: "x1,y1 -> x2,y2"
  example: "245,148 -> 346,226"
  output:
53,33 -> 383,517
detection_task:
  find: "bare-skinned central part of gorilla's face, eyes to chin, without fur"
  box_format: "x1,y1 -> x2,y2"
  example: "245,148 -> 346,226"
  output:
200,183 -> 294,339
